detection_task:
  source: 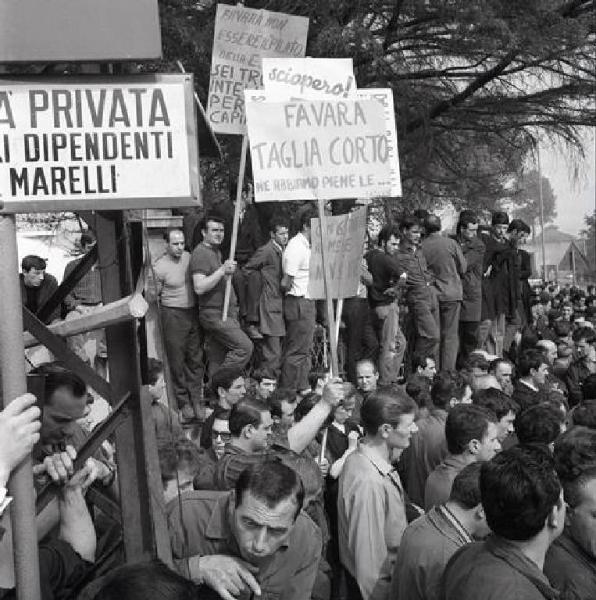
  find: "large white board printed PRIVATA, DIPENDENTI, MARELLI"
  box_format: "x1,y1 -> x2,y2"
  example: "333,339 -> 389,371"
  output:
0,75 -> 199,212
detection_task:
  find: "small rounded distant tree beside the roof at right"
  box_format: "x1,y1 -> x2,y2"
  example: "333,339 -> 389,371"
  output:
510,169 -> 557,234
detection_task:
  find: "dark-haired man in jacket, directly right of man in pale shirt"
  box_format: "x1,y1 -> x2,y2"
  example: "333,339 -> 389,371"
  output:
402,371 -> 471,506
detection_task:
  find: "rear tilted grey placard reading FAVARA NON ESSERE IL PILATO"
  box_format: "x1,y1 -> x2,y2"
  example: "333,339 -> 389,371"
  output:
207,4 -> 308,134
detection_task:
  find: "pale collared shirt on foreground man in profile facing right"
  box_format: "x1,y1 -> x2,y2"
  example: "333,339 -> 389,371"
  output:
337,444 -> 407,600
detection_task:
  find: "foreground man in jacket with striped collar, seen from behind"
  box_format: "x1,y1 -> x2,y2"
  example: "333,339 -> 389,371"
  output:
390,463 -> 490,600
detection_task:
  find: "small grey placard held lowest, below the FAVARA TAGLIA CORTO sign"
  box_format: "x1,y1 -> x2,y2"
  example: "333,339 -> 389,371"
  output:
308,208 -> 366,299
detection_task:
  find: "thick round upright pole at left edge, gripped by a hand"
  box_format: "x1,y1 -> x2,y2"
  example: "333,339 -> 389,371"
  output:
0,215 -> 41,600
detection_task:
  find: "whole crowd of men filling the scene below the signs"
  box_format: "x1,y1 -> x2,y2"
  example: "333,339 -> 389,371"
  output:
0,204 -> 596,600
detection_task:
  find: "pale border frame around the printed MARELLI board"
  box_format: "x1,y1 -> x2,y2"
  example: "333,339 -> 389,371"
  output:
0,73 -> 202,214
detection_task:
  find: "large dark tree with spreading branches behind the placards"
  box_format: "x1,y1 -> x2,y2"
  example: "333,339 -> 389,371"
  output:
153,0 -> 596,213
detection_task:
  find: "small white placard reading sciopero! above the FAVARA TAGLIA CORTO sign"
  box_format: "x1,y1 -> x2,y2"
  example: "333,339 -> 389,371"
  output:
263,58 -> 356,100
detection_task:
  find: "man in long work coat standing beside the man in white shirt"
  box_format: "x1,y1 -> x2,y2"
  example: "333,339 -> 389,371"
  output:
243,218 -> 288,378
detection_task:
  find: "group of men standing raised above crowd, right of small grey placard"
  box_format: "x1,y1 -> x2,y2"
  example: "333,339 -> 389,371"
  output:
366,210 -> 530,384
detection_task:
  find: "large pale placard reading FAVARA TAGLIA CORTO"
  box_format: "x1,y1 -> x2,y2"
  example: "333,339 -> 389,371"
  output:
246,94 -> 401,202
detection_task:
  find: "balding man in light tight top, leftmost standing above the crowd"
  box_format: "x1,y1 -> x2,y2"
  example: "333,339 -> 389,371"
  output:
153,229 -> 203,421
